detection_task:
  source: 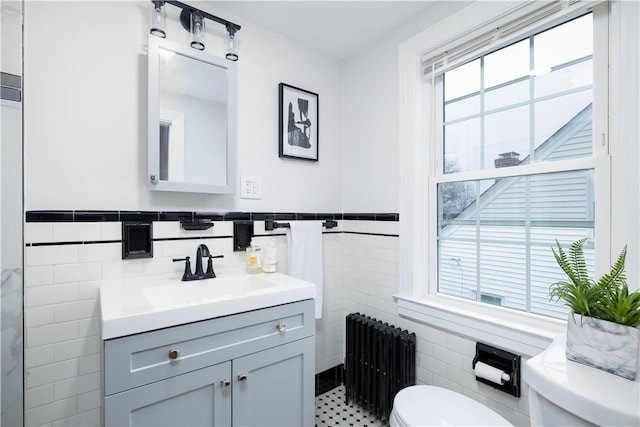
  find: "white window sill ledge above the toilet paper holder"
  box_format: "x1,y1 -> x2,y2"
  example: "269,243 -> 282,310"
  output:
395,295 -> 567,357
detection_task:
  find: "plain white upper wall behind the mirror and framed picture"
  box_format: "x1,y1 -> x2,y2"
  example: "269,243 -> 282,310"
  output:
24,1 -> 342,212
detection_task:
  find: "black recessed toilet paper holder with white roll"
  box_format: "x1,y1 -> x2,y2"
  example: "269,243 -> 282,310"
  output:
473,343 -> 521,397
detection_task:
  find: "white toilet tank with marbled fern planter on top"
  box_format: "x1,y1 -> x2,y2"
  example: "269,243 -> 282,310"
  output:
522,335 -> 640,427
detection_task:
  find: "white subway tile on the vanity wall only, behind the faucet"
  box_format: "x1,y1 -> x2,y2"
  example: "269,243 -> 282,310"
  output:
25,221 -> 343,426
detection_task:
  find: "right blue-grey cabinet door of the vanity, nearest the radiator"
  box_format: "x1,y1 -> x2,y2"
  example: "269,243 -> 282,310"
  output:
233,337 -> 315,427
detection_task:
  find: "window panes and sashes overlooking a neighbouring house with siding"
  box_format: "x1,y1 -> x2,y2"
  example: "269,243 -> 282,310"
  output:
425,12 -> 606,318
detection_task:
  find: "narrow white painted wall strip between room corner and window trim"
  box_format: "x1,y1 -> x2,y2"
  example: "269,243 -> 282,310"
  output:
342,1 -> 469,212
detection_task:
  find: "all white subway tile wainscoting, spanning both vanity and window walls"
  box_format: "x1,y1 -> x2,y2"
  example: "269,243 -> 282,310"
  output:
25,220 -> 529,426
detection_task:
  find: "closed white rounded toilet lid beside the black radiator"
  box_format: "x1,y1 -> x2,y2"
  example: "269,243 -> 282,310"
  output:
393,385 -> 512,427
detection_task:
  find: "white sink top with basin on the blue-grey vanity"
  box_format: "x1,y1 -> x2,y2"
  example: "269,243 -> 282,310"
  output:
100,273 -> 315,339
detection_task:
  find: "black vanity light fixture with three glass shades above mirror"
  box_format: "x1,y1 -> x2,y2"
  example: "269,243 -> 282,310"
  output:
149,0 -> 241,61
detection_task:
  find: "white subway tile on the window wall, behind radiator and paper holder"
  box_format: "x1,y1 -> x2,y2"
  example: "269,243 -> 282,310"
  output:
342,221 -> 530,426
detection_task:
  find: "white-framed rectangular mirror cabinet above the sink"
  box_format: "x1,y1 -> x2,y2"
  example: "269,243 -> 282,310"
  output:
148,36 -> 236,194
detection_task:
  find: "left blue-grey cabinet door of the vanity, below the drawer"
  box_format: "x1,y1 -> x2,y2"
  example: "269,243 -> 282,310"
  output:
104,362 -> 231,427
